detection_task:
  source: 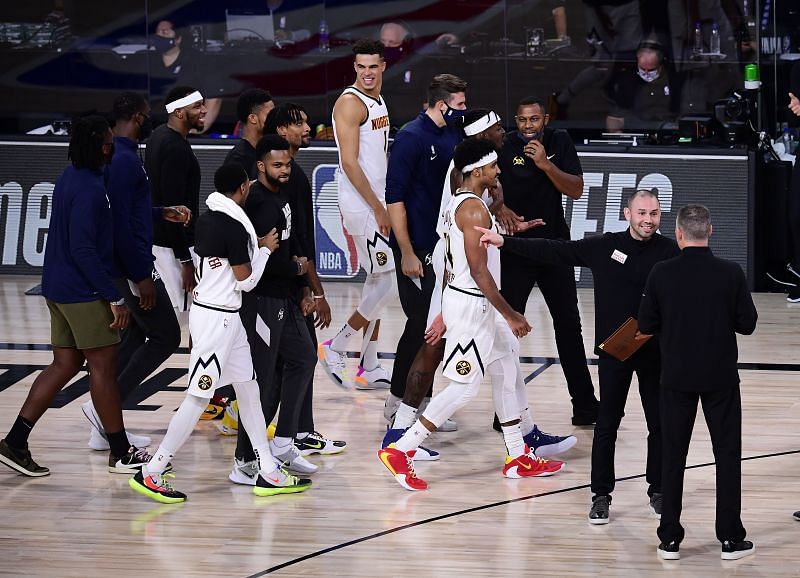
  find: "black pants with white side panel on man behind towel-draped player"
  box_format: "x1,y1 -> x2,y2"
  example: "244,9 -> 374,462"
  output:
236,294 -> 317,461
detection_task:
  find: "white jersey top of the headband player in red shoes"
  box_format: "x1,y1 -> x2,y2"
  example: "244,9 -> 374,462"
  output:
444,191 -> 500,293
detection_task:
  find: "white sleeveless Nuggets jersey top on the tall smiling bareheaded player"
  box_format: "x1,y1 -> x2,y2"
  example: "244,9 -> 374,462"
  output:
333,86 -> 389,212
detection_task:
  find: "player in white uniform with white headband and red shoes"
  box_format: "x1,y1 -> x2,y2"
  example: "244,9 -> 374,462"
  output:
378,139 -> 564,491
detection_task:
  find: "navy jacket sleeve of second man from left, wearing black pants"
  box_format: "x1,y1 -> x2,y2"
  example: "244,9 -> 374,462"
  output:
106,157 -> 153,283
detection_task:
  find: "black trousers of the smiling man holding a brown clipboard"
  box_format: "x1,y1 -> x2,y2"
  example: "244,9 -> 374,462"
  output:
592,343 -> 662,496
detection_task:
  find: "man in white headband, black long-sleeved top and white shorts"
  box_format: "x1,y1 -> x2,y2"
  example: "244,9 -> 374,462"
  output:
144,86 -> 206,324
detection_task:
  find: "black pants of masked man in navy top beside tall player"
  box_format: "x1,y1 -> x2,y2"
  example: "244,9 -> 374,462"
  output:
391,248 -> 436,399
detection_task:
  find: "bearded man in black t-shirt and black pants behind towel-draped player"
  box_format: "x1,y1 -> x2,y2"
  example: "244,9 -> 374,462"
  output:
229,135 -> 317,485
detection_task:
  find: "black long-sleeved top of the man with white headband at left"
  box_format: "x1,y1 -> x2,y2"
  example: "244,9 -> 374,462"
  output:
144,124 -> 200,260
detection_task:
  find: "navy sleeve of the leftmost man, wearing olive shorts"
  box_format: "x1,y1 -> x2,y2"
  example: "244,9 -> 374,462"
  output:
69,194 -> 122,301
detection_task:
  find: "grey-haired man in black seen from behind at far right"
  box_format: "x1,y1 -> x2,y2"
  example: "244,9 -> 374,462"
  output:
639,205 -> 758,560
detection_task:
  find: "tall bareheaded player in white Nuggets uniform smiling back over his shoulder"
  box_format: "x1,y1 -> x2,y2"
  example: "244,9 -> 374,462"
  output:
318,40 -> 397,389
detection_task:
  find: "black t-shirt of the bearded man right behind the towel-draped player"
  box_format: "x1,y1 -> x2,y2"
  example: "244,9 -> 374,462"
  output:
244,182 -> 301,299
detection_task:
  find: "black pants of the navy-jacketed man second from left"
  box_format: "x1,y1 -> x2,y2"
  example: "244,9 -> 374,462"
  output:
114,279 -> 181,408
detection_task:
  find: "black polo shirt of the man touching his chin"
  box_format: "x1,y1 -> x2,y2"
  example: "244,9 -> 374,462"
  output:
498,128 -> 583,239
